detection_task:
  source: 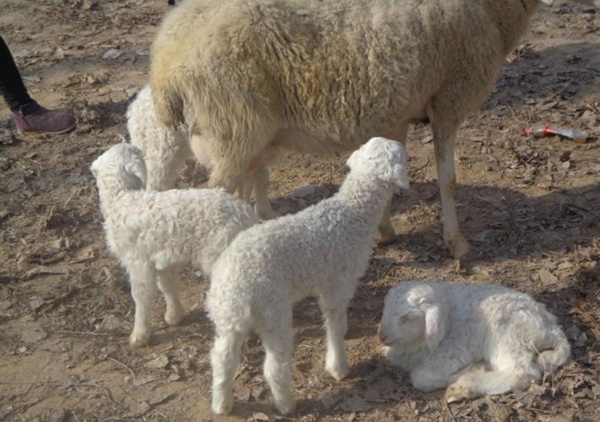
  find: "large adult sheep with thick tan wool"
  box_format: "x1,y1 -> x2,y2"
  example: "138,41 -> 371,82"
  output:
151,0 -> 600,258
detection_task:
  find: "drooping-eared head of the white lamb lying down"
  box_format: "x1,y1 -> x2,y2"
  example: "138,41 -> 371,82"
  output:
379,282 -> 448,350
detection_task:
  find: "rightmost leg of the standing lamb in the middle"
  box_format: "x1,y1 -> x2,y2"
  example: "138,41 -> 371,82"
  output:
319,297 -> 350,380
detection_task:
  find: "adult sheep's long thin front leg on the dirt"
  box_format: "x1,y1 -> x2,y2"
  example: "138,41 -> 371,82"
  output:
430,117 -> 469,259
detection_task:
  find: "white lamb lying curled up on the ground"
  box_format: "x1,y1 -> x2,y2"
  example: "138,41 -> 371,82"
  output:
379,281 -> 571,402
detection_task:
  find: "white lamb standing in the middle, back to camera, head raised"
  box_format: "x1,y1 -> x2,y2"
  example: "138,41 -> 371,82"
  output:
207,138 -> 408,414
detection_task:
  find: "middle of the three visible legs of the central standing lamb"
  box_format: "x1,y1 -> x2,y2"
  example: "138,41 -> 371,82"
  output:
259,318 -> 296,415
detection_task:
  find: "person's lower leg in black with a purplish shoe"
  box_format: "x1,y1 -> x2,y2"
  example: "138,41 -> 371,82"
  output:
0,37 -> 75,133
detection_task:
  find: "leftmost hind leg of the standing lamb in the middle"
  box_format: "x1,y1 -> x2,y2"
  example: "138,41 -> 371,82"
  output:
210,329 -> 246,415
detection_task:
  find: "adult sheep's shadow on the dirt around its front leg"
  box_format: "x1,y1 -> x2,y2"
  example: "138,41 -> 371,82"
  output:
273,182 -> 600,265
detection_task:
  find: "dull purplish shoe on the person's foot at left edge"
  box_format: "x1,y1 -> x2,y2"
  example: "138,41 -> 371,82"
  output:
12,101 -> 75,133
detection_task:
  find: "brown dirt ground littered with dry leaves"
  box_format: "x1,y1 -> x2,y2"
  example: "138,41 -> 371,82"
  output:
0,0 -> 600,422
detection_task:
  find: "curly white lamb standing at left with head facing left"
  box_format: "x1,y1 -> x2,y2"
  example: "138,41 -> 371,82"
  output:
91,143 -> 257,347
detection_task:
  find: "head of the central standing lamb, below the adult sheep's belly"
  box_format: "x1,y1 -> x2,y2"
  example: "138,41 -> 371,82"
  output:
346,138 -> 408,189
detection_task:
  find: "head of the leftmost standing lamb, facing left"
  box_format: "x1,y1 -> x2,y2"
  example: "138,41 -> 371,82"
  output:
90,143 -> 146,190
